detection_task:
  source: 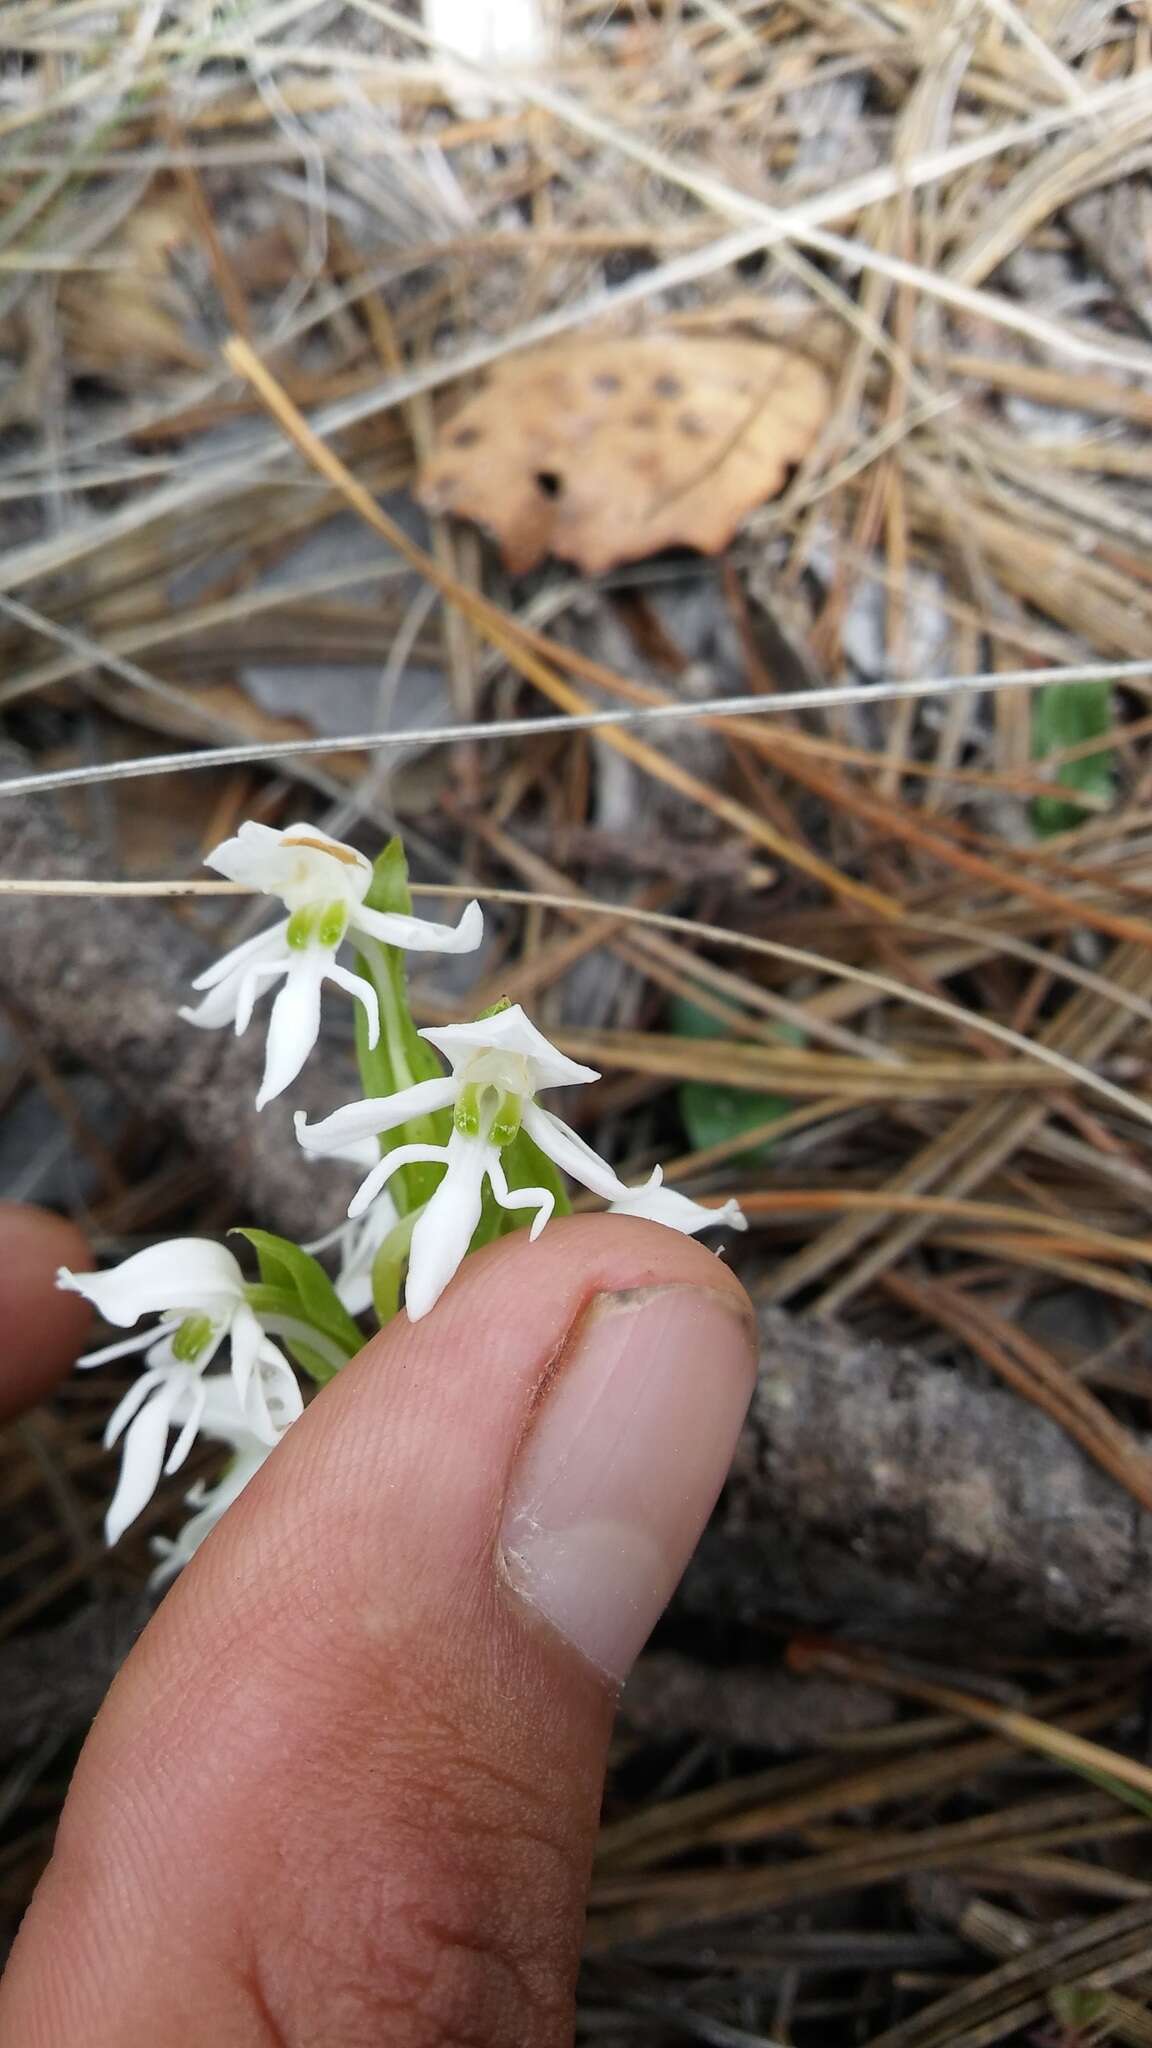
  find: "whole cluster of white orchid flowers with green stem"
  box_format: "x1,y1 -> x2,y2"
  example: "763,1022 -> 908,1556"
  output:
57,823 -> 744,1581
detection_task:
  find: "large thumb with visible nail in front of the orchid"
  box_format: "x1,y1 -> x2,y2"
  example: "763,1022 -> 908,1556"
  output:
0,1217 -> 752,2048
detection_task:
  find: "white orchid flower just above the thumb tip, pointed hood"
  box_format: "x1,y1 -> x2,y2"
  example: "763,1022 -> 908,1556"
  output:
295,1004 -> 746,1323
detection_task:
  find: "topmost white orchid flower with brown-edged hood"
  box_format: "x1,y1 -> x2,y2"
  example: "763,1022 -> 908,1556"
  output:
180,823 -> 484,1110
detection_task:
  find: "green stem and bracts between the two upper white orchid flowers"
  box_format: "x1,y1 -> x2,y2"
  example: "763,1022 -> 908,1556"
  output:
357,840 -> 451,1217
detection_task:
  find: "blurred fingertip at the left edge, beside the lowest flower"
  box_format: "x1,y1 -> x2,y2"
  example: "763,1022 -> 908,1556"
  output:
0,1202 -> 92,1421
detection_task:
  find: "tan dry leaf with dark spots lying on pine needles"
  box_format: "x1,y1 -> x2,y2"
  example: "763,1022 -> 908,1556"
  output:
418,334 -> 830,575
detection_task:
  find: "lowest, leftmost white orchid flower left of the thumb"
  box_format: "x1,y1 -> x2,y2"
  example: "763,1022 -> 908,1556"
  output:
55,1237 -> 303,1544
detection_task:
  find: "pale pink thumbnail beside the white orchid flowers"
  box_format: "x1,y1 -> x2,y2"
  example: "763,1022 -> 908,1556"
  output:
502,1286 -> 756,1679
